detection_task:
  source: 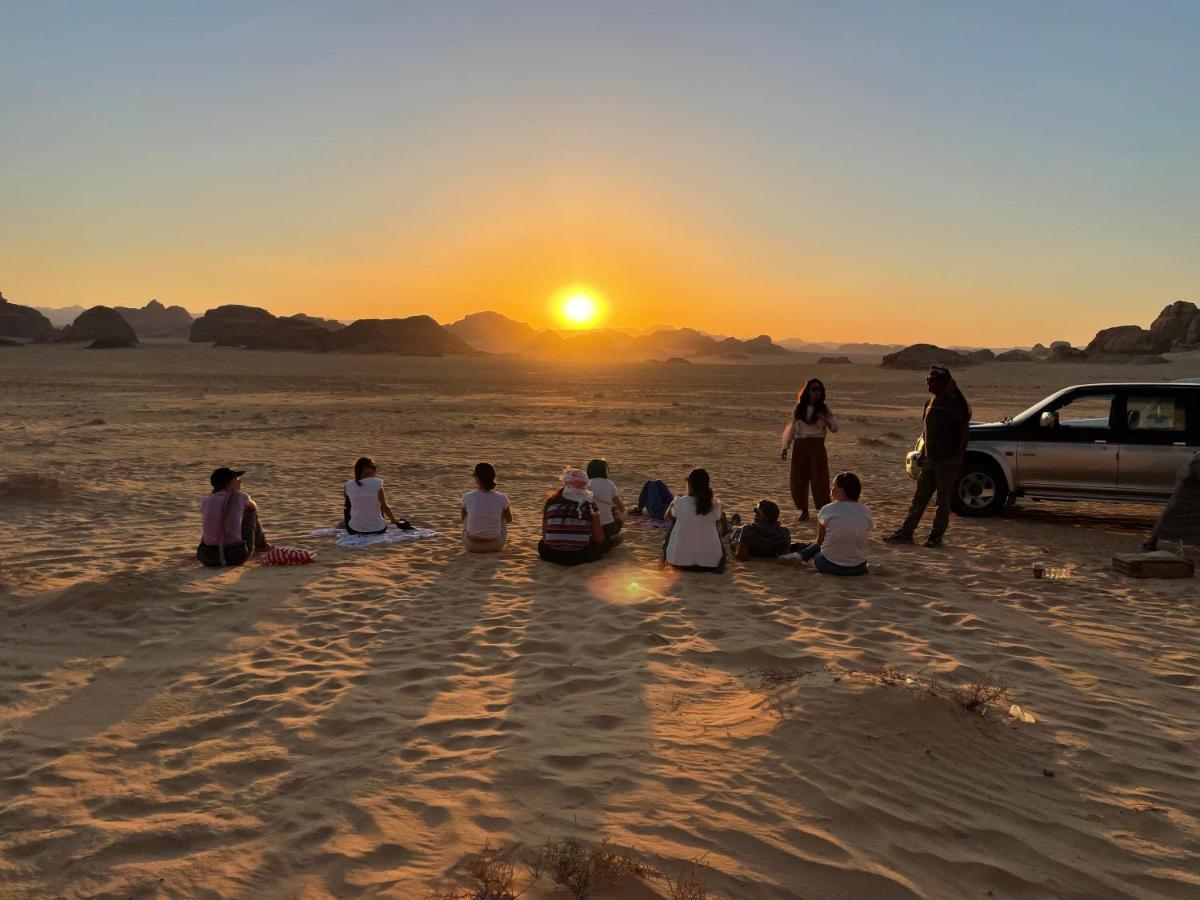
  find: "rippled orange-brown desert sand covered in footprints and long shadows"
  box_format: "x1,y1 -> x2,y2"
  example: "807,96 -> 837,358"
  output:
0,343 -> 1200,899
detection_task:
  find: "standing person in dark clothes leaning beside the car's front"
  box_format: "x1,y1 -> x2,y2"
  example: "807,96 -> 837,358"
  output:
883,366 -> 971,547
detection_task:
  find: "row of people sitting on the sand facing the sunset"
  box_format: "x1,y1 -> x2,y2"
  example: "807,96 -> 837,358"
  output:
197,456 -> 874,575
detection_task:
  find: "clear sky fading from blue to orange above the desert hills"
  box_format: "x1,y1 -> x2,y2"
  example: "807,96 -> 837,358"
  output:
0,0 -> 1200,346
